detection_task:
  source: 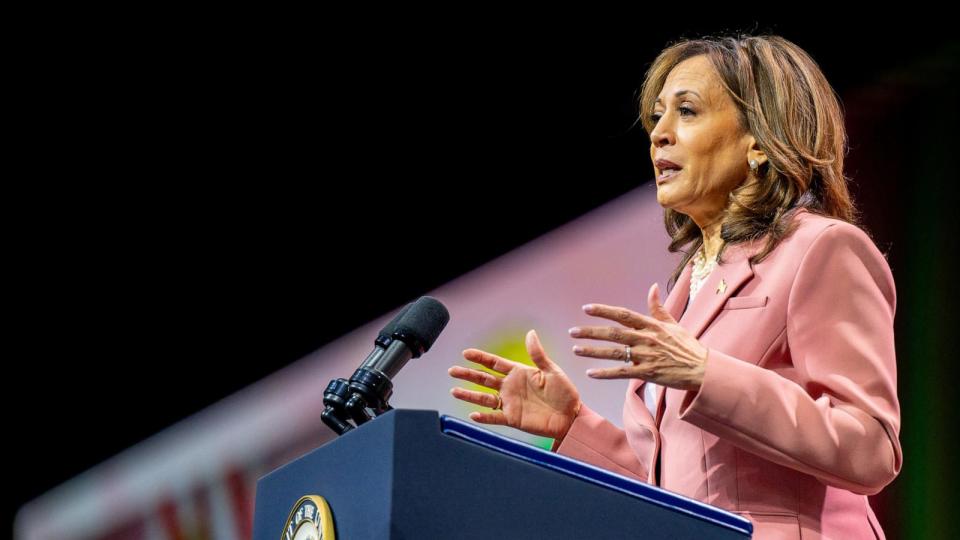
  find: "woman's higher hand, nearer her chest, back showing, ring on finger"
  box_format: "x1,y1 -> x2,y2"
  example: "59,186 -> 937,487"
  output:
570,283 -> 707,391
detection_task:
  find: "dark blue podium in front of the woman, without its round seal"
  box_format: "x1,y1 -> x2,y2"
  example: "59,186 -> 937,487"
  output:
253,409 -> 753,540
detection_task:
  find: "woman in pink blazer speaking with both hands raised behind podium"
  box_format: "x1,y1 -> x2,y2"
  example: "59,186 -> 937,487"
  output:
450,36 -> 902,539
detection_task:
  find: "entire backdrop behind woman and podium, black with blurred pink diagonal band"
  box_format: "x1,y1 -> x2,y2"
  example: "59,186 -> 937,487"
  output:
9,9 -> 960,538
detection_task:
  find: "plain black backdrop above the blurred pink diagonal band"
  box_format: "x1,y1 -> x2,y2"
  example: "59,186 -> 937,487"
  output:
4,10 -> 955,532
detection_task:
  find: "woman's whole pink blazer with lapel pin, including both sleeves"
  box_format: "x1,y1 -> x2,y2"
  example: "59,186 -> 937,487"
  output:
555,210 -> 902,539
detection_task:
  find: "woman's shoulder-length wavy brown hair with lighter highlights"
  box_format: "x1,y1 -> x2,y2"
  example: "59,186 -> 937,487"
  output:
639,36 -> 859,287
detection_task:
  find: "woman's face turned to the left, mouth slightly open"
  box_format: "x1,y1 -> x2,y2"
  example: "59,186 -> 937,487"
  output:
645,55 -> 756,228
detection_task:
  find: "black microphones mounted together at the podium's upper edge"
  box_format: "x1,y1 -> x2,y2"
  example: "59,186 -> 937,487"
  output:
321,296 -> 450,435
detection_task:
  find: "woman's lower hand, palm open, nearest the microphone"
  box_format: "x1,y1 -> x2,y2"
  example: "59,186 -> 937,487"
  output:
447,330 -> 580,440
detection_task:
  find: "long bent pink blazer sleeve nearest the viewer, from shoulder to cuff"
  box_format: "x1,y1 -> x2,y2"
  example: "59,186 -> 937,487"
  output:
680,223 -> 903,495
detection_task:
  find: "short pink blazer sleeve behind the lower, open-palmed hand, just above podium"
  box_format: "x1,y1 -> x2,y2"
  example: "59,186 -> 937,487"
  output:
552,404 -> 647,482
